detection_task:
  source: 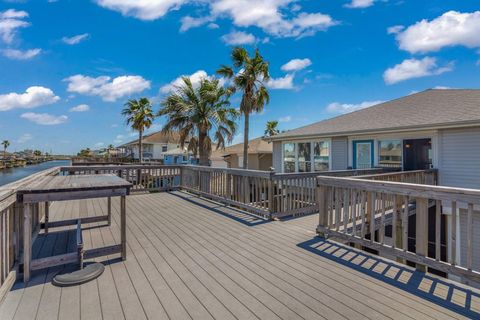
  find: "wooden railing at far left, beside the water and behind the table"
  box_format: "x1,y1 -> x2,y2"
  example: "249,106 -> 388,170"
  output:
0,168 -> 59,301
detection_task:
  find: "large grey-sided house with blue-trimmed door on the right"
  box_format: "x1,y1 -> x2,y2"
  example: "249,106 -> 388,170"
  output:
269,90 -> 480,276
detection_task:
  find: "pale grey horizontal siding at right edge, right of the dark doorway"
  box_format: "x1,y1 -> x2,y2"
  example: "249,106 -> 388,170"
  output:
438,128 -> 480,189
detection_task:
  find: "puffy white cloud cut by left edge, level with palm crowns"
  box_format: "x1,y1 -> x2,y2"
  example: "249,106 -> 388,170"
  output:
0,86 -> 60,111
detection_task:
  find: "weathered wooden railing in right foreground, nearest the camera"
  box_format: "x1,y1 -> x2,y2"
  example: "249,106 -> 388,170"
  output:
317,172 -> 480,281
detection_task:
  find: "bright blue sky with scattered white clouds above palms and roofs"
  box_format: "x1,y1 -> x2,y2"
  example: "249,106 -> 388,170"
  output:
0,0 -> 480,154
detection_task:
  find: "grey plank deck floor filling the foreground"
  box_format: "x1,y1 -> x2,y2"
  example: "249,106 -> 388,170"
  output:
0,192 -> 480,320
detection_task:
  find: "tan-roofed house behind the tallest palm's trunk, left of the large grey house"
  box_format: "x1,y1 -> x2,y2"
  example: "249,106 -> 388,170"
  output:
218,137 -> 272,171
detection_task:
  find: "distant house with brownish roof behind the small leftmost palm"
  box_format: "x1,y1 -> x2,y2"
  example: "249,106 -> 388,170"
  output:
119,131 -> 185,161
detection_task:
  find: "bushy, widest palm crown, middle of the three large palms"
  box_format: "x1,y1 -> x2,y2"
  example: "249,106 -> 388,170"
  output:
158,77 -> 238,166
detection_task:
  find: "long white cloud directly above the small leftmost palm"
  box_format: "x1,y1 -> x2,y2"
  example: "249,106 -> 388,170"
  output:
64,74 -> 150,101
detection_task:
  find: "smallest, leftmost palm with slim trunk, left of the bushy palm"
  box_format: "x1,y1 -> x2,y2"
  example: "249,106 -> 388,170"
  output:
122,98 -> 155,163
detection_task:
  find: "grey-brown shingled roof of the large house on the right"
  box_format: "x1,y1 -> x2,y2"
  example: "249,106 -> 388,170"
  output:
270,89 -> 480,140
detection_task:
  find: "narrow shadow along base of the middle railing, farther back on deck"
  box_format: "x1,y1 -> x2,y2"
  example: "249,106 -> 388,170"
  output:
169,191 -> 271,227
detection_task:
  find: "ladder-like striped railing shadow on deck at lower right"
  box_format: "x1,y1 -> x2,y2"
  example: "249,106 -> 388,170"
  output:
298,237 -> 480,319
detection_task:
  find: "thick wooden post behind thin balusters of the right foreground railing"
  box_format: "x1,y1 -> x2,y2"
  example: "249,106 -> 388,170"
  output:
415,198 -> 428,272
